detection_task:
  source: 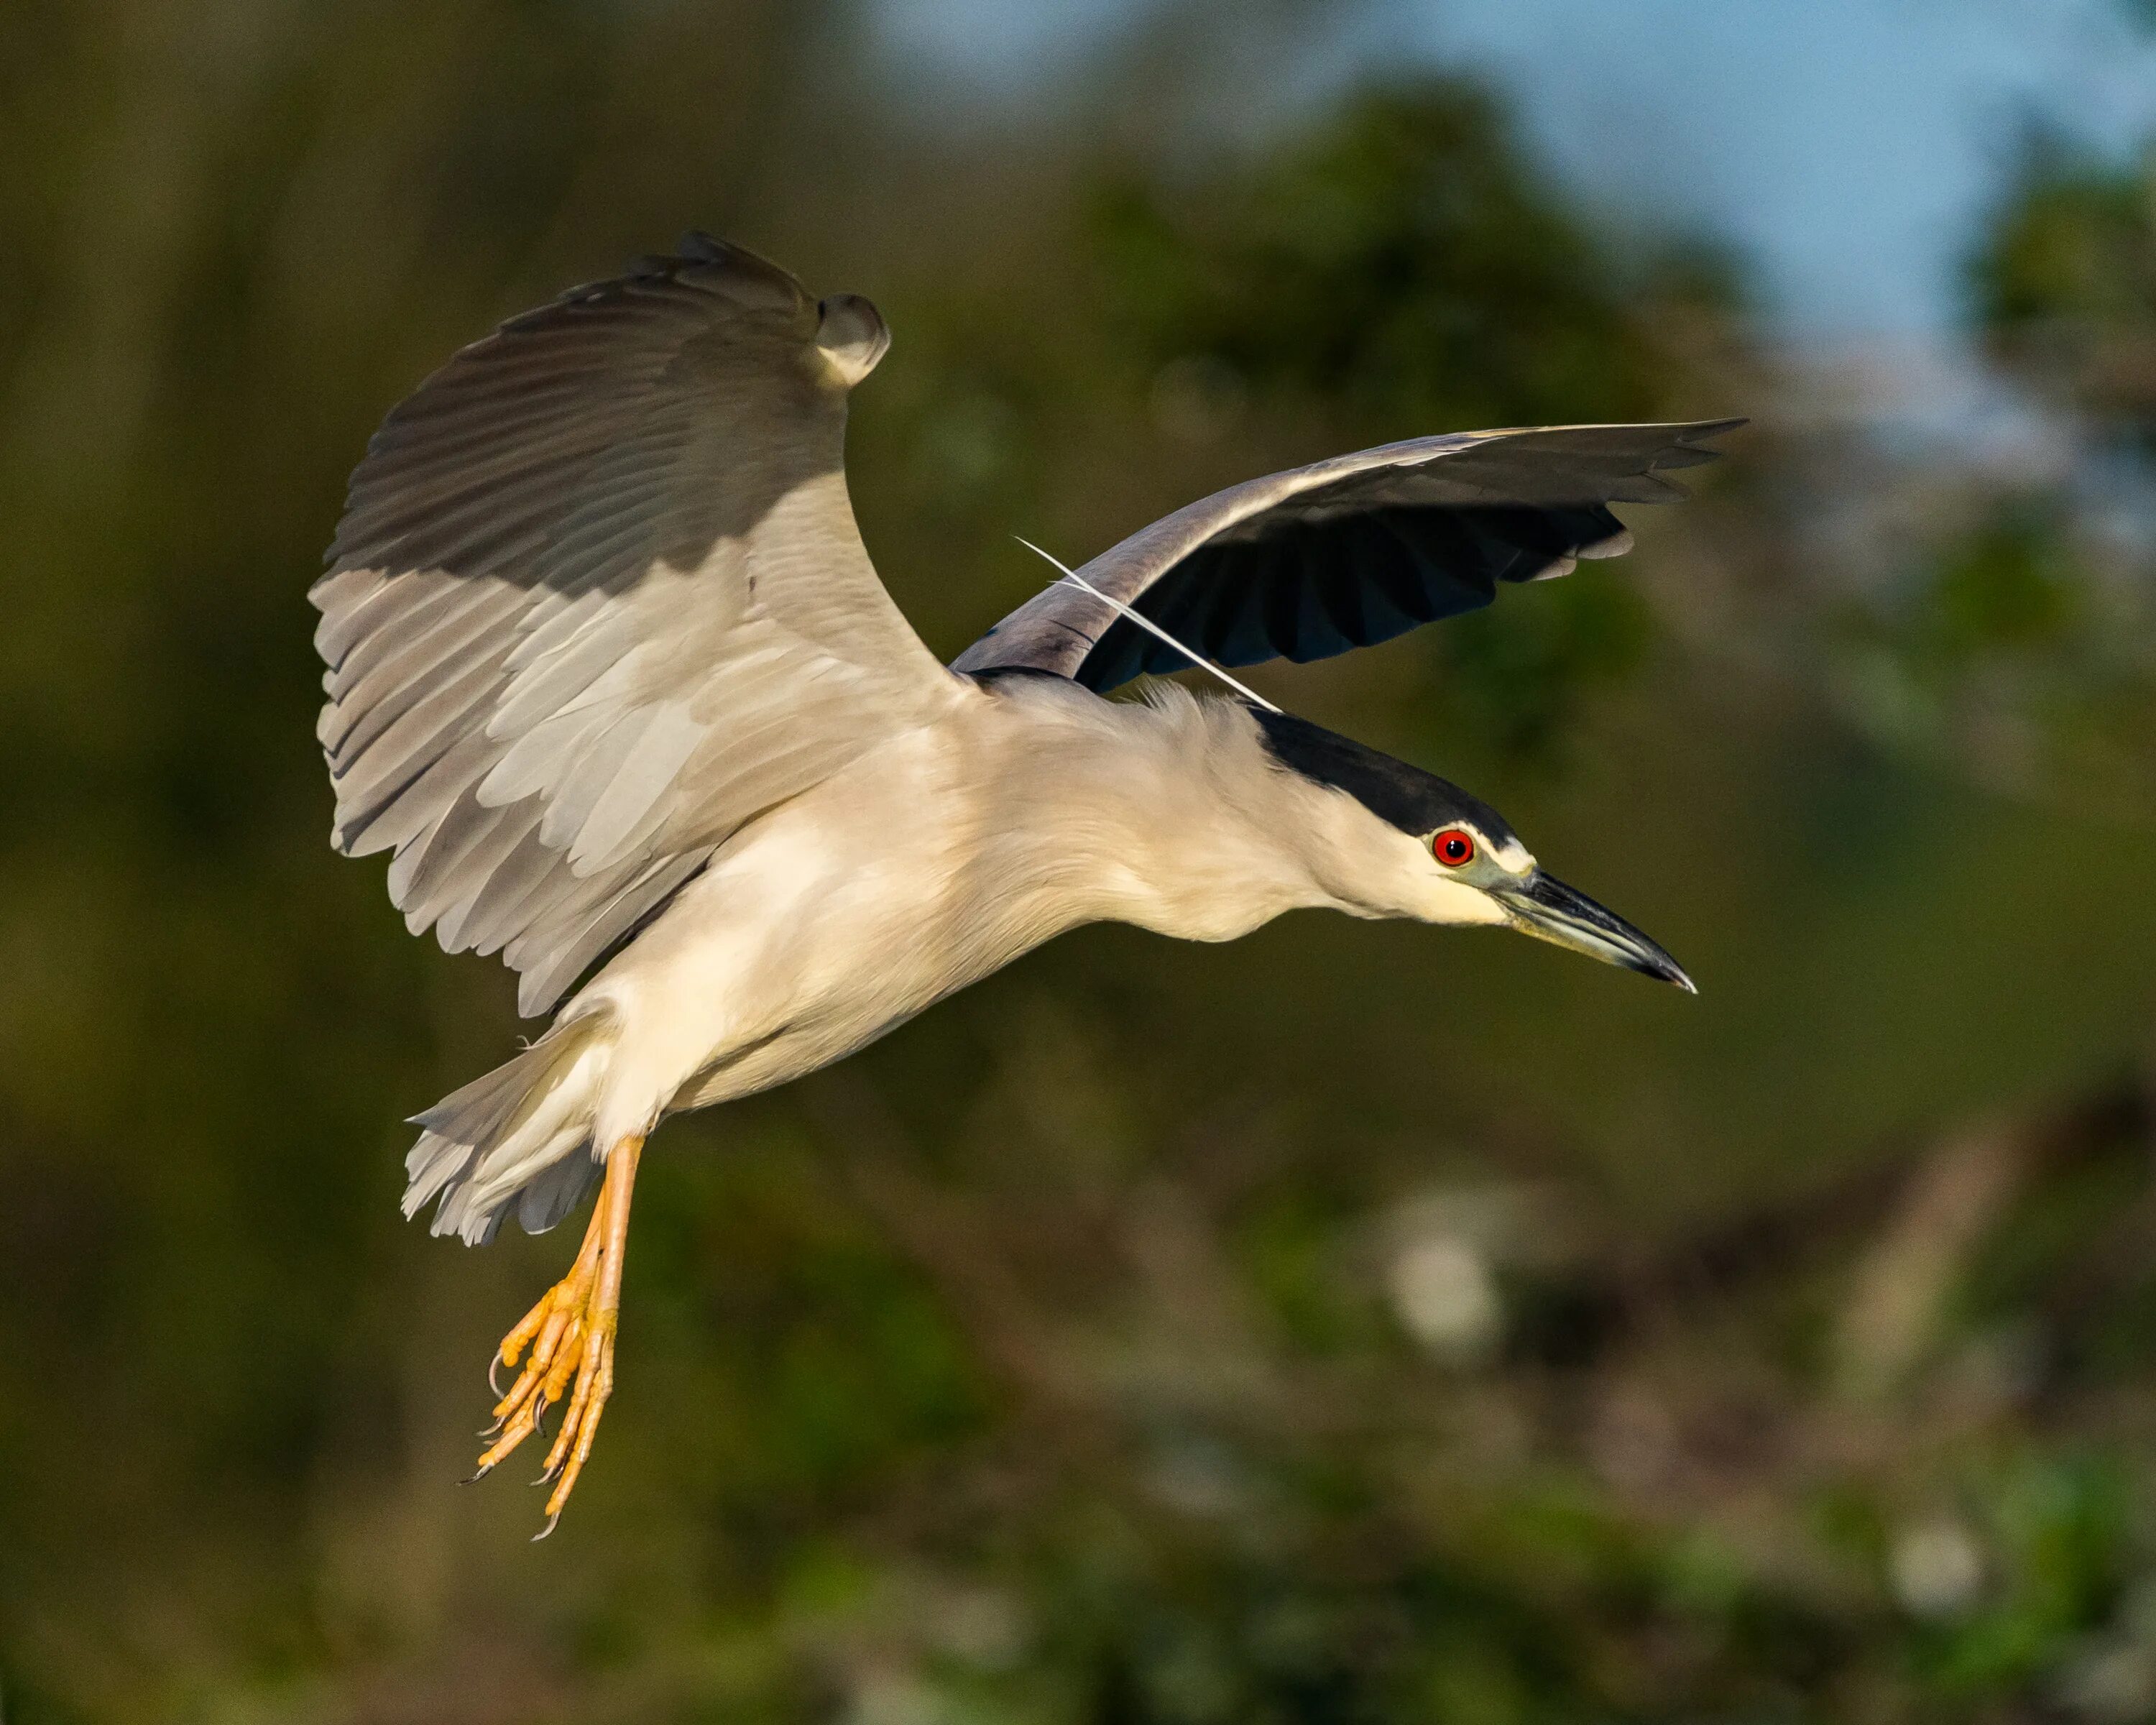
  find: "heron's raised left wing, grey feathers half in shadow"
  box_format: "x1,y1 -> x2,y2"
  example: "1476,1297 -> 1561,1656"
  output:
310,235 -> 959,1013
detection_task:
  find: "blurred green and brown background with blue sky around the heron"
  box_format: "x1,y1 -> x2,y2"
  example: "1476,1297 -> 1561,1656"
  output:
0,0 -> 2156,1725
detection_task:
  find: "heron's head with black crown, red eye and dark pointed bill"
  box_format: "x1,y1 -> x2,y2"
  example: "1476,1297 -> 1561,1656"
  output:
1253,709 -> 1697,994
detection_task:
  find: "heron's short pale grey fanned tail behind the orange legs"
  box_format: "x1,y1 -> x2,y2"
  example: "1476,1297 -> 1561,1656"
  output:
403,1011 -> 614,1246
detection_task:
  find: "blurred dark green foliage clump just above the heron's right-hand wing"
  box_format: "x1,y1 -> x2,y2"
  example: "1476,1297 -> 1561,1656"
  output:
1095,84 -> 1736,436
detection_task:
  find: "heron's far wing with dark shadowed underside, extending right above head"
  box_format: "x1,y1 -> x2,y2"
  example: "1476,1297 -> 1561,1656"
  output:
951,418 -> 1744,690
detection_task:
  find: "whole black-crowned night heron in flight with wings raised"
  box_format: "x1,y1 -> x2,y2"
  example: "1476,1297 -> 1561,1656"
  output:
313,235 -> 1738,1529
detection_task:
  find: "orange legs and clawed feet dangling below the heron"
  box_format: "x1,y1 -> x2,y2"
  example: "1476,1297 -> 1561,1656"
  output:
472,1136 -> 645,1540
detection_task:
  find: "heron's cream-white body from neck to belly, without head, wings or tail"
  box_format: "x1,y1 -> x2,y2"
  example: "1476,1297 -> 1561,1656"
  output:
561,679 -> 1326,1126
